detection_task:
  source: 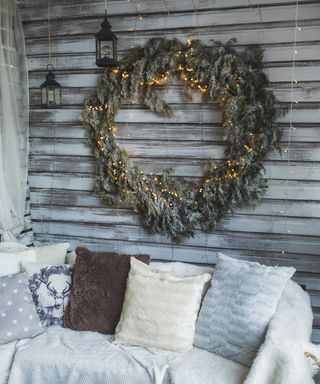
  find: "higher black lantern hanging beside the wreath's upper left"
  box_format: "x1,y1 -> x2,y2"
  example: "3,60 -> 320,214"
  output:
95,12 -> 117,67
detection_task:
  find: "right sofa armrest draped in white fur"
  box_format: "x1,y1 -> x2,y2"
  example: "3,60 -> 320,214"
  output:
244,281 -> 314,384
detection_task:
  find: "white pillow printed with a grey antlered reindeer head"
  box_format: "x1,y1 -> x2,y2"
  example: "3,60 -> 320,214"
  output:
22,263 -> 72,326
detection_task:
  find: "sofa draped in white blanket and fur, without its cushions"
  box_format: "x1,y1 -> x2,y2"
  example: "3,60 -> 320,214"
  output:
0,242 -> 320,384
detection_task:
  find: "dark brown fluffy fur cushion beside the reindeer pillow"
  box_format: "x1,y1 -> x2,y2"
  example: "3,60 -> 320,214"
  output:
63,247 -> 150,334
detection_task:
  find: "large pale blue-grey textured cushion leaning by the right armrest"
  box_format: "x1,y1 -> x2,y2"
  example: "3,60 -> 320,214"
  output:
194,253 -> 295,366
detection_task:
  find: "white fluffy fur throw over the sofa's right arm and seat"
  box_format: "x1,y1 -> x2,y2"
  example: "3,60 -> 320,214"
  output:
168,281 -> 320,384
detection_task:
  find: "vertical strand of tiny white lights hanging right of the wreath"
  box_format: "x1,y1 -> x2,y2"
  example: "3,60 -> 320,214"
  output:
280,0 -> 301,254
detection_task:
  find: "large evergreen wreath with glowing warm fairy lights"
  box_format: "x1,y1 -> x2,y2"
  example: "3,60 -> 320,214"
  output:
82,38 -> 281,242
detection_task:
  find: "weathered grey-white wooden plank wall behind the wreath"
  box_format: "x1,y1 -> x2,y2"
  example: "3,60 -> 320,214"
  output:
20,0 -> 320,341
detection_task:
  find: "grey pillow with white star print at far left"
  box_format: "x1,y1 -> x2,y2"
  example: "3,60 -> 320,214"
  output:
0,273 -> 44,344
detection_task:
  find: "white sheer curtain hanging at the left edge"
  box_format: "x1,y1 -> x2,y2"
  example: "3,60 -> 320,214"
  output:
0,0 -> 29,241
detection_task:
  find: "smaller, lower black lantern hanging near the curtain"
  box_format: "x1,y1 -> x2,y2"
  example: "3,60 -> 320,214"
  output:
40,64 -> 61,108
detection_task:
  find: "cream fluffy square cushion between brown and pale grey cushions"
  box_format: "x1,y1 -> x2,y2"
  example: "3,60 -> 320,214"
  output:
114,257 -> 211,352
